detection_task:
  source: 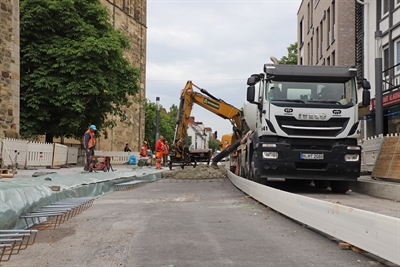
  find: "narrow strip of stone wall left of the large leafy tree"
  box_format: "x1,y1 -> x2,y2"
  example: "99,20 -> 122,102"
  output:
0,0 -> 20,137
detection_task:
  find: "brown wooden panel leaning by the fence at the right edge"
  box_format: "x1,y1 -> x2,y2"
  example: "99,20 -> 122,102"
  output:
372,136 -> 400,181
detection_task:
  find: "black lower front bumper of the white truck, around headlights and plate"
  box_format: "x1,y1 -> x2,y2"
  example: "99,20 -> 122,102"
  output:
254,143 -> 361,181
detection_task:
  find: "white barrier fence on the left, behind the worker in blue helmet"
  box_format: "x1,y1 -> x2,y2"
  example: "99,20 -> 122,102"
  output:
0,138 -> 139,168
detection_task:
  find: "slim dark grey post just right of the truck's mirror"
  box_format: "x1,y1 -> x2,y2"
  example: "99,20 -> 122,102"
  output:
375,30 -> 383,135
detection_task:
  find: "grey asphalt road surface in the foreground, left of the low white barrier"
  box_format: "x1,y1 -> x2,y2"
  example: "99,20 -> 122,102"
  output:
0,178 -> 390,267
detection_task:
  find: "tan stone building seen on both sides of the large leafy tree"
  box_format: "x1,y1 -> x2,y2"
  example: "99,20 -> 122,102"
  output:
0,0 -> 147,151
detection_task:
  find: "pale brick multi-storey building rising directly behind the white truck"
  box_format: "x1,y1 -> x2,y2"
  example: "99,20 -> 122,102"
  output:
297,0 -> 356,66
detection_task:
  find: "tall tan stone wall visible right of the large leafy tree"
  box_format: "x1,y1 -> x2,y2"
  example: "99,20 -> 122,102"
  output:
96,0 -> 147,151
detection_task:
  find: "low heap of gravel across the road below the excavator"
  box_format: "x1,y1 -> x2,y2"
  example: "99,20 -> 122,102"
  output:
163,164 -> 227,180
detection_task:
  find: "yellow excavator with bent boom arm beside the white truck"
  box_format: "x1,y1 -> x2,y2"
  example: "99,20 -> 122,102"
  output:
168,81 -> 244,169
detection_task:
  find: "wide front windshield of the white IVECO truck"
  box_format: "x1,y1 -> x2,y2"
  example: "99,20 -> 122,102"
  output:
265,80 -> 357,105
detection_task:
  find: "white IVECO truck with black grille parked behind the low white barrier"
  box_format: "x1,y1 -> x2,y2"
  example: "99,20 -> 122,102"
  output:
236,64 -> 370,193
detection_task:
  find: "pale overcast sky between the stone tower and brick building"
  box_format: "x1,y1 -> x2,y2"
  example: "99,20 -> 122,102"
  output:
146,0 -> 301,138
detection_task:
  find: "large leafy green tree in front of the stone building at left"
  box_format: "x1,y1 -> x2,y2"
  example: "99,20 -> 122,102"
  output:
20,0 -> 140,140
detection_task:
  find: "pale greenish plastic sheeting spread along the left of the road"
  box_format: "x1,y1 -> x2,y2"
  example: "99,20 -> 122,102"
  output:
0,169 -> 162,230
